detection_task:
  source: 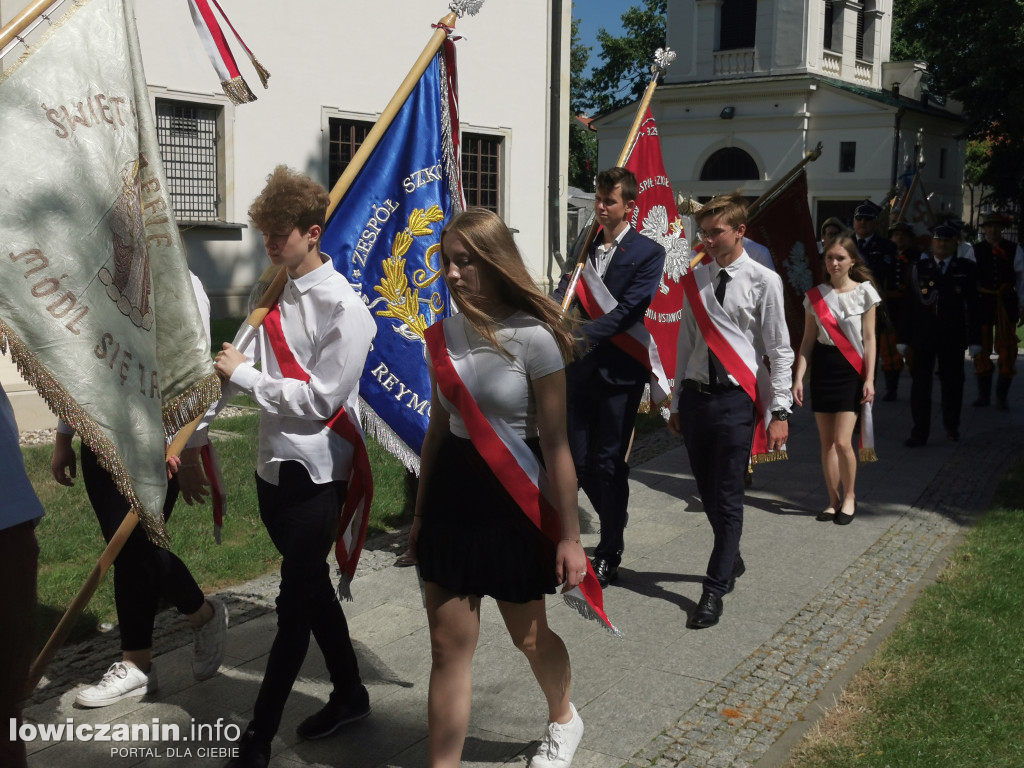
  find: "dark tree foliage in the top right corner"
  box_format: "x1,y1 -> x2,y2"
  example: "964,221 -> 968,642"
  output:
892,0 -> 1024,210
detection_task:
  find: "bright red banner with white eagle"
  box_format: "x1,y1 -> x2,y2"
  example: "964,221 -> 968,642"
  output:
626,109 -> 690,404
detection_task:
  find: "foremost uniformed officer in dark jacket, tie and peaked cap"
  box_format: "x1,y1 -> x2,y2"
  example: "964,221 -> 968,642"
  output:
905,224 -> 980,447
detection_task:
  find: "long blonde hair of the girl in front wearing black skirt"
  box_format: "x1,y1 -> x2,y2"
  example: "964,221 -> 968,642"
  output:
441,208 -> 574,360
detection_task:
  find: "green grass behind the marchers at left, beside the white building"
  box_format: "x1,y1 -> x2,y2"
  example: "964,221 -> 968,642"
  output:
29,414 -> 416,645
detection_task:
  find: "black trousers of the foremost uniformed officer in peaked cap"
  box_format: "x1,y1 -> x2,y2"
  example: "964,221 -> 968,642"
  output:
910,340 -> 967,440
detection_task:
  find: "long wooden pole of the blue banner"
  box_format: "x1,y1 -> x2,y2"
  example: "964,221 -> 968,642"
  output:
24,0 -> 471,695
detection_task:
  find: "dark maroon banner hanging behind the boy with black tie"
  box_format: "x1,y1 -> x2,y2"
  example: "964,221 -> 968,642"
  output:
746,171 -> 822,349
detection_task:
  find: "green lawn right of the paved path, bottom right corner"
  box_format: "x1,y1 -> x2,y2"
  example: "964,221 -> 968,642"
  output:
791,459 -> 1024,768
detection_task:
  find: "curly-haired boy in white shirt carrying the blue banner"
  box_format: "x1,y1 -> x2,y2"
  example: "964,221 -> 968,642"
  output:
214,166 -> 376,768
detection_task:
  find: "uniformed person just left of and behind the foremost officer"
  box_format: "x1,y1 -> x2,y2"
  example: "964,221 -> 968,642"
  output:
874,221 -> 921,400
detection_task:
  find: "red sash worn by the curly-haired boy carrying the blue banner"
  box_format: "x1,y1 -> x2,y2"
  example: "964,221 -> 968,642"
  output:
263,303 -> 374,600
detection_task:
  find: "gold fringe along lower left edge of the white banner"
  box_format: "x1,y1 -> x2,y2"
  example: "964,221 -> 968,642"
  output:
0,319 -> 171,547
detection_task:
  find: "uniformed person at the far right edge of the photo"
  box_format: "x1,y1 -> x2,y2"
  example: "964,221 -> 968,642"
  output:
974,213 -> 1024,411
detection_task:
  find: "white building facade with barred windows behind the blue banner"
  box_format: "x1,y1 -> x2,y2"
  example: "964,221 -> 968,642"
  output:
0,0 -> 571,429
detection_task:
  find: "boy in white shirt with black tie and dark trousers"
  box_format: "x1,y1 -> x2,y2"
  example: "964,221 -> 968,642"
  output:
669,195 -> 794,629
